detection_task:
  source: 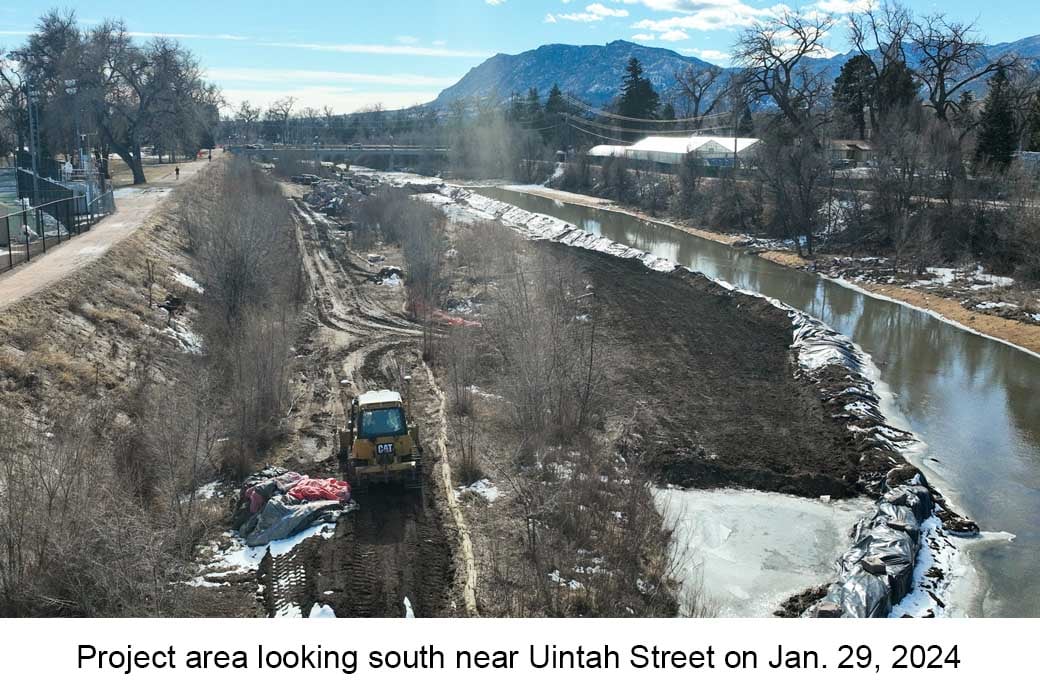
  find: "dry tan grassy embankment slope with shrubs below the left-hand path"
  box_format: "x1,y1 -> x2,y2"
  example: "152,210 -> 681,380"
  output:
0,156 -> 298,616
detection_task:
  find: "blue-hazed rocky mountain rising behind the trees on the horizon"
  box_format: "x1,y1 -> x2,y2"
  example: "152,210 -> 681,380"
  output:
434,35 -> 1040,108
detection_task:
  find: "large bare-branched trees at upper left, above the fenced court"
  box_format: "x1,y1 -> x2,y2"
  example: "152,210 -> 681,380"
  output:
0,10 -> 223,183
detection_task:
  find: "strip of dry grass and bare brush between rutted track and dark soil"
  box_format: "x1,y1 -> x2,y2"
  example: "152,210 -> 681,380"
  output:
422,218 -> 711,616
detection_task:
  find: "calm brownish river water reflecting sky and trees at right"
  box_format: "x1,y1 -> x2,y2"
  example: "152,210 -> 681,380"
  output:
480,188 -> 1040,617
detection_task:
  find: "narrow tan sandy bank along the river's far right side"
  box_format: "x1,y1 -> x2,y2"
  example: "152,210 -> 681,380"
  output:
502,185 -> 1040,356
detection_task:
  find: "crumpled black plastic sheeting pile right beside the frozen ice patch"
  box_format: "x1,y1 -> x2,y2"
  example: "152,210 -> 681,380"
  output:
806,474 -> 935,618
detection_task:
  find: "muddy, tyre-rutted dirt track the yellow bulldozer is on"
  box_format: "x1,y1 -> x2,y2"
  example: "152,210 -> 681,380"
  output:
251,197 -> 454,617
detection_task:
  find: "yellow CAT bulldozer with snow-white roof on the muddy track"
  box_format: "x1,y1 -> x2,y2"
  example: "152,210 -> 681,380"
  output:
339,391 -> 422,490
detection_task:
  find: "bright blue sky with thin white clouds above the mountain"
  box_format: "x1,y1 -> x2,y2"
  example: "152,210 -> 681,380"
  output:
0,0 -> 1040,111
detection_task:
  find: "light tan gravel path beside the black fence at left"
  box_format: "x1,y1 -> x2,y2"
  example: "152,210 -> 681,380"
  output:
0,160 -> 208,311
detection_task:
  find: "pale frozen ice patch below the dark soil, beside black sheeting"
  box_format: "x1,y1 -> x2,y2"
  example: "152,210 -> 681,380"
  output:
654,489 -> 874,618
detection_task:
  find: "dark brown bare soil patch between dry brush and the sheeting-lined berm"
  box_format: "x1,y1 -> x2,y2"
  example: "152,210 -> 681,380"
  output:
541,242 -> 869,497
